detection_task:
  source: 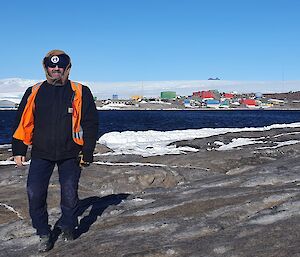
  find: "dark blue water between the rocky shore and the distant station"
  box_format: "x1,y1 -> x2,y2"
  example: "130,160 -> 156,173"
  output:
0,110 -> 300,144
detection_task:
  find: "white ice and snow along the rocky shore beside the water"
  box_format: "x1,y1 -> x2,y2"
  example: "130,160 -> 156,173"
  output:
98,122 -> 300,157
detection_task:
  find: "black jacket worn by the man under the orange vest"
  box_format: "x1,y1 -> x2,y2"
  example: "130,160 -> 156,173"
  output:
12,81 -> 98,162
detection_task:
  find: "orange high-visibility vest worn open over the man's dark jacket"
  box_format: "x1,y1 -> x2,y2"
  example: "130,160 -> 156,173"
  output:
13,81 -> 84,145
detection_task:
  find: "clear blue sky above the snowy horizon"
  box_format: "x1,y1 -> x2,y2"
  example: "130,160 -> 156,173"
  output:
0,0 -> 300,81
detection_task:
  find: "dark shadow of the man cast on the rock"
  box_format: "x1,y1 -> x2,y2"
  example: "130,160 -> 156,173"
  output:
53,194 -> 130,241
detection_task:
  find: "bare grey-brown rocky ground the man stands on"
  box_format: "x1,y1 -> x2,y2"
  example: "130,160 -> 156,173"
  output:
0,128 -> 300,257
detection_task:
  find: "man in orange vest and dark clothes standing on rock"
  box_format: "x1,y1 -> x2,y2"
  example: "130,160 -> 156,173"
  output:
12,50 -> 98,252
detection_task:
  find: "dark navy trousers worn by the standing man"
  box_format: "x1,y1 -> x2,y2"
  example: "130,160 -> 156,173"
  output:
27,158 -> 81,235
